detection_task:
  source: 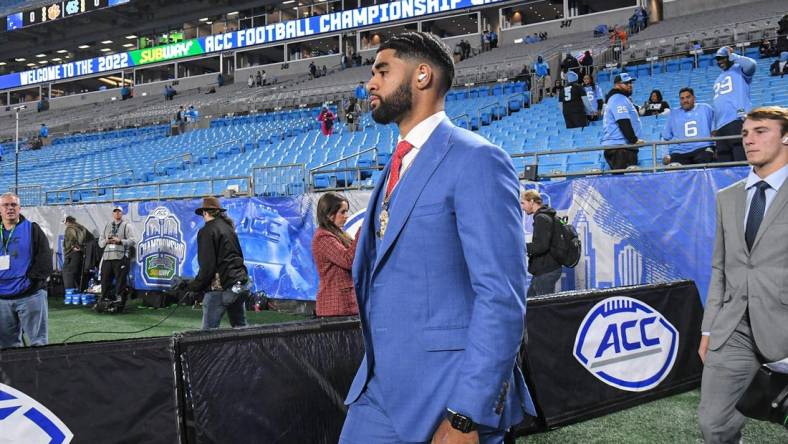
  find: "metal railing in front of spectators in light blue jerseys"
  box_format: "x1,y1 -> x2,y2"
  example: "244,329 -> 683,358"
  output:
512,135 -> 748,179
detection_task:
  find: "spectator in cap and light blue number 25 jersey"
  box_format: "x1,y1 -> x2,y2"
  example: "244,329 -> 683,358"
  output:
601,72 -> 643,170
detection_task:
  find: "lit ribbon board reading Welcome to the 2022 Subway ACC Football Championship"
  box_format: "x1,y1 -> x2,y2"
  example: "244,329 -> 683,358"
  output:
0,0 -> 504,90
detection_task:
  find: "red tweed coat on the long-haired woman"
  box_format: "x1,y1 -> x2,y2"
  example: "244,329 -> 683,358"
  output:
312,228 -> 358,316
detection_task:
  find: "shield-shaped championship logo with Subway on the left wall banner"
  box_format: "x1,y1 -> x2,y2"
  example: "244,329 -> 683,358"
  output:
137,207 -> 186,286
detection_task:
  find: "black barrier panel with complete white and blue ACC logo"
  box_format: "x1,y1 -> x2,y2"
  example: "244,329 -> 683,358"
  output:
526,281 -> 703,428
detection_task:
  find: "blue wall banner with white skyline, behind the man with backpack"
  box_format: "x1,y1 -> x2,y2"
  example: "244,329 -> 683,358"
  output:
525,167 -> 749,301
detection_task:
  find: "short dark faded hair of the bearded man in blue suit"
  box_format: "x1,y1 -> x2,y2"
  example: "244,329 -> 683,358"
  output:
377,32 -> 454,94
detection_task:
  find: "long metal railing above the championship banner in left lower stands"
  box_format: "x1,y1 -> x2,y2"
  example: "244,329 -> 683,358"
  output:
43,176 -> 252,205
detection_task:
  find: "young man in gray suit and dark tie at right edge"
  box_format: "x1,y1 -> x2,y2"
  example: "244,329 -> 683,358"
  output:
698,106 -> 788,443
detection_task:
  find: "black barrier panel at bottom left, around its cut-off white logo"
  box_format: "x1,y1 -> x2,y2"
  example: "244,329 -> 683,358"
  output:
0,338 -> 179,444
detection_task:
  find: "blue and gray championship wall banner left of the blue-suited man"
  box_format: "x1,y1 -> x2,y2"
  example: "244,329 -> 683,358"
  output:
22,192 -> 369,300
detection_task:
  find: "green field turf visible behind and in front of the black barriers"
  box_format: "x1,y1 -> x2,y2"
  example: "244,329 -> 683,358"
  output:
49,299 -> 788,444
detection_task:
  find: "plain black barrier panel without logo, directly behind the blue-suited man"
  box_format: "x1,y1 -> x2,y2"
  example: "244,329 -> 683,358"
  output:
179,318 -> 364,444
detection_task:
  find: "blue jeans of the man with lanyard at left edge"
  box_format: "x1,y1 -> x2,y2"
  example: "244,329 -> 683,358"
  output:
0,290 -> 49,348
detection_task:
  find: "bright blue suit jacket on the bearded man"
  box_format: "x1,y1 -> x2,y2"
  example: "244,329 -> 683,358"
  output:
346,119 -> 535,441
